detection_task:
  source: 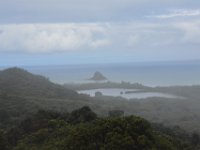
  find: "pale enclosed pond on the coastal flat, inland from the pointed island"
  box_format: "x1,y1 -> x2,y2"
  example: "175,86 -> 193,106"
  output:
78,88 -> 180,99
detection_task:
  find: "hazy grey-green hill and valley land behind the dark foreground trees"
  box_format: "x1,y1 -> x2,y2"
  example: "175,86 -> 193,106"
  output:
0,68 -> 200,135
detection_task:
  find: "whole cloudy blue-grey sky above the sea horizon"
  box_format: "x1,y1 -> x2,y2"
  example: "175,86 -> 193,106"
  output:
0,0 -> 200,66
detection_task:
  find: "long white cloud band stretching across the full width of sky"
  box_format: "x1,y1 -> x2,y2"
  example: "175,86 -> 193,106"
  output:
0,20 -> 200,53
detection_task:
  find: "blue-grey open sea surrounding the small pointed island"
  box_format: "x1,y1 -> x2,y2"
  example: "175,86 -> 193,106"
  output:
25,64 -> 200,86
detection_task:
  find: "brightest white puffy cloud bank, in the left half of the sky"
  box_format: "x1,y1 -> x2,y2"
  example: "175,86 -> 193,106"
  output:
0,24 -> 109,53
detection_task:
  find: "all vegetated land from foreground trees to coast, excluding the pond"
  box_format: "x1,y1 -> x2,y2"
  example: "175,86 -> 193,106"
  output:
0,68 -> 200,150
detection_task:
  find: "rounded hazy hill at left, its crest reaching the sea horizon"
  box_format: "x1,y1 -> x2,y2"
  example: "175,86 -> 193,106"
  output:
0,68 -> 77,98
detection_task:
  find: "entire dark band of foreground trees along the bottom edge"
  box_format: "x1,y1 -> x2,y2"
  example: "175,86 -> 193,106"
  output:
0,106 -> 200,150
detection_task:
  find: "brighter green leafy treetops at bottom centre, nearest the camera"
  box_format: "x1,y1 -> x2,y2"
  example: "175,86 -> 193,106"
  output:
12,112 -> 180,150
